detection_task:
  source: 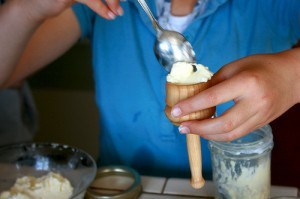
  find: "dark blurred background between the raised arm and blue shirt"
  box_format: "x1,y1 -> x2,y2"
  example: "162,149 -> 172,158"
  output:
28,41 -> 99,159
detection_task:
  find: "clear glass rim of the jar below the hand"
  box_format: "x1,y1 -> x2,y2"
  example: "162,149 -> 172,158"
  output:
209,125 -> 273,156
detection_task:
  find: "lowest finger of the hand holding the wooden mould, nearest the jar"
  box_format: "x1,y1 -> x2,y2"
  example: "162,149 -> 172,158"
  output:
202,113 -> 265,142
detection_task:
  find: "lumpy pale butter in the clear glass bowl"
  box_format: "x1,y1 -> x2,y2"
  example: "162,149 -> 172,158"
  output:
0,172 -> 73,199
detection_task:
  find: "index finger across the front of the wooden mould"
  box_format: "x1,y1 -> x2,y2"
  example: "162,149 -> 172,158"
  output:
171,76 -> 245,117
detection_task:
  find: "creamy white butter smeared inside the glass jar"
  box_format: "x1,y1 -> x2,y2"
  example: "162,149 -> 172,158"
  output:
213,155 -> 270,199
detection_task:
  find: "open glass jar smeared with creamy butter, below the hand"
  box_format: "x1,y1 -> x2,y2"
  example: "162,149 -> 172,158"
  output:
209,125 -> 273,199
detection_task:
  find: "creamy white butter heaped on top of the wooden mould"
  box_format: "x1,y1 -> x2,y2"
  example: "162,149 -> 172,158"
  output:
167,62 -> 213,85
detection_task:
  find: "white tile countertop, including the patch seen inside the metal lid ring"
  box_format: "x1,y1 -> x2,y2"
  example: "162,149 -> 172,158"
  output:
86,175 -> 299,199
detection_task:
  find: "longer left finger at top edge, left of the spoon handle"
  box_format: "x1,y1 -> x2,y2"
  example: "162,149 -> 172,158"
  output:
76,0 -> 116,19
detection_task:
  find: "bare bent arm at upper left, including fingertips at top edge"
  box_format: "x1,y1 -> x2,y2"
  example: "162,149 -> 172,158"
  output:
0,0 -> 122,88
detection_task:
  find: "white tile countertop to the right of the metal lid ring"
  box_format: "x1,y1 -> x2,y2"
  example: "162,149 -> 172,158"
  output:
139,176 -> 298,199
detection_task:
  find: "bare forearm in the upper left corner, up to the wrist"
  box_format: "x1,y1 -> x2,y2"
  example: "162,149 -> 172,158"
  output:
0,0 -> 41,84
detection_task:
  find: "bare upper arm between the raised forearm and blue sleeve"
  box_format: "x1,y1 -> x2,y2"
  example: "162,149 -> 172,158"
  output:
3,8 -> 80,87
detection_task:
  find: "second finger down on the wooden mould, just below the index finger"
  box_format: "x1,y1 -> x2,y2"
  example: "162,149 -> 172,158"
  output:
180,99 -> 256,135
